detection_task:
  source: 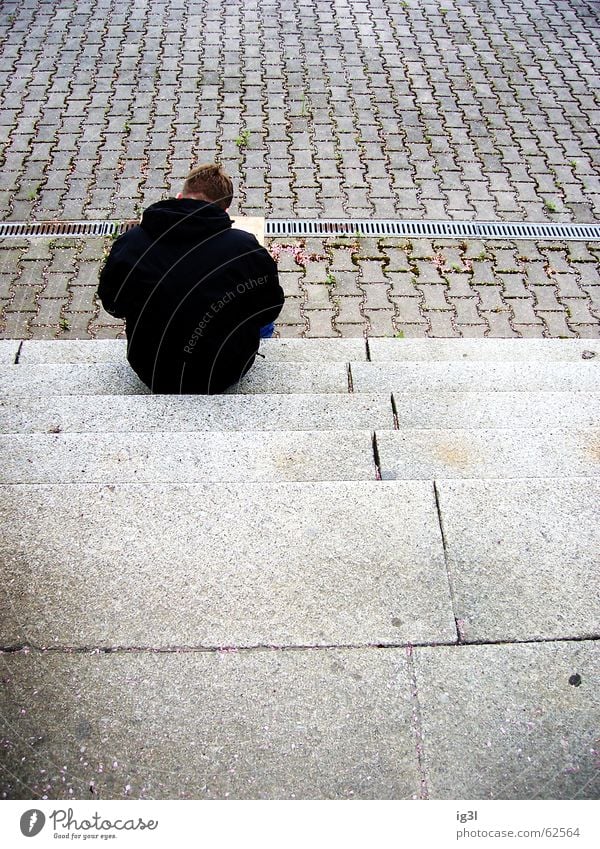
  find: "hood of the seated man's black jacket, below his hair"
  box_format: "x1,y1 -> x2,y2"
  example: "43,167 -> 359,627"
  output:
141,198 -> 231,239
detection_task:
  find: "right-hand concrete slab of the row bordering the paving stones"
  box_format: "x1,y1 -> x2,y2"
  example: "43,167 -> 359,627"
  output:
369,339 -> 600,363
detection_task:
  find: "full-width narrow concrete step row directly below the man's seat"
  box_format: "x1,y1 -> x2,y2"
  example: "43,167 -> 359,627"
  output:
0,392 -> 600,433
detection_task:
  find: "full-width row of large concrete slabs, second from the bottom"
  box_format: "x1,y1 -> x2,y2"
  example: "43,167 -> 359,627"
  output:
0,478 -> 600,647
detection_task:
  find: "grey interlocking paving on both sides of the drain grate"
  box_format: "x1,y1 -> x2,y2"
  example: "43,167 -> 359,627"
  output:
0,0 -> 600,337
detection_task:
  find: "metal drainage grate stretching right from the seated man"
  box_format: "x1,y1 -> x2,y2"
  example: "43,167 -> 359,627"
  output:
265,218 -> 600,242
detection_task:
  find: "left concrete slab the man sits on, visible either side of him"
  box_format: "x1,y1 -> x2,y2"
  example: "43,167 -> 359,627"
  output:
0,360 -> 348,396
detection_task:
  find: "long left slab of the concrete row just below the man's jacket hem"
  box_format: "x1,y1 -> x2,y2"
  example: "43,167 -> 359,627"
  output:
0,393 -> 396,433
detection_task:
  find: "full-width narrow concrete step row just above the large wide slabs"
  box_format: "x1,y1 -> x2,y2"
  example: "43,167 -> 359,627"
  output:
0,427 -> 600,483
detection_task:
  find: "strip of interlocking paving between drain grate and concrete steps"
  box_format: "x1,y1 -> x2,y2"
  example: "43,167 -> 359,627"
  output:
0,238 -> 600,339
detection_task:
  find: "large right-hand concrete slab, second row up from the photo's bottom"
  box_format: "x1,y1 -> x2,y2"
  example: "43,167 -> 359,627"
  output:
437,478 -> 600,642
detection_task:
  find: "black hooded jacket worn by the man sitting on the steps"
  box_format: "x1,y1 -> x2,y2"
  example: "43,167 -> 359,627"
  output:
98,198 -> 284,394
